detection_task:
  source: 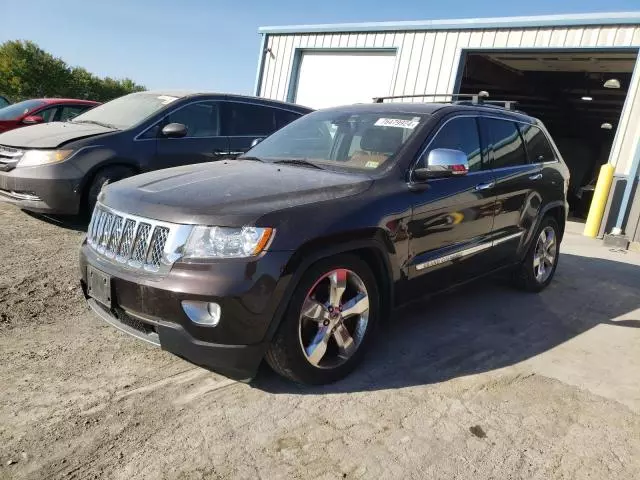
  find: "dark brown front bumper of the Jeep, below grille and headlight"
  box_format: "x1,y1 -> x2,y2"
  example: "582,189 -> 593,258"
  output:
80,243 -> 290,380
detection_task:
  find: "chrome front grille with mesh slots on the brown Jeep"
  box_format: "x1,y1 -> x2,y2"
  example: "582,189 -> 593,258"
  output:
87,204 -> 191,273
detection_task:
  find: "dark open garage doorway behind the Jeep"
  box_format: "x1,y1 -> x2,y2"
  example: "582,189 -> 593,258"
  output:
458,49 -> 638,219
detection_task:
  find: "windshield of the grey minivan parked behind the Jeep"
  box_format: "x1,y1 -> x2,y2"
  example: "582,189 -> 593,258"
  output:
71,92 -> 178,130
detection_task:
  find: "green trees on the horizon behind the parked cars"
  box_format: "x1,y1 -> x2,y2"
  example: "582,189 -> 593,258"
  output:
0,40 -> 145,102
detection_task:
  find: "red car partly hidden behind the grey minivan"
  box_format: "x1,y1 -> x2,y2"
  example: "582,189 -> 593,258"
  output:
0,98 -> 100,133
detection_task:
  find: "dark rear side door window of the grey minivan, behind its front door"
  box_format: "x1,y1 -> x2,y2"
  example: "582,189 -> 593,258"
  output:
224,102 -> 276,137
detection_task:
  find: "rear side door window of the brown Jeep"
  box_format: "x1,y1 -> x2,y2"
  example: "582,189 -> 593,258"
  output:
483,118 -> 528,168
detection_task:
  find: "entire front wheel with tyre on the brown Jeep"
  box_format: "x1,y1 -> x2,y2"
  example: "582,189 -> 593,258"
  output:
266,255 -> 380,385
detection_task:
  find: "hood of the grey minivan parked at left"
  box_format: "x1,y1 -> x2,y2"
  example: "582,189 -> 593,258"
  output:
0,122 -> 113,148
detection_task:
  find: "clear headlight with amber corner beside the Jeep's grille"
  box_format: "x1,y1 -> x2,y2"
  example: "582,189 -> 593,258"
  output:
183,226 -> 275,258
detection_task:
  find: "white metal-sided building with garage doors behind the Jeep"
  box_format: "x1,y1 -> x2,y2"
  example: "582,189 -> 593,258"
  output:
255,12 -> 640,246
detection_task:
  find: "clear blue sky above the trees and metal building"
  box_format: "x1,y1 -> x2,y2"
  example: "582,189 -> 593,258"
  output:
0,0 -> 640,93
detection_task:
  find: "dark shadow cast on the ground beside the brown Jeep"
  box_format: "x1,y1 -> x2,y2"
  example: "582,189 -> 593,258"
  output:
253,254 -> 640,394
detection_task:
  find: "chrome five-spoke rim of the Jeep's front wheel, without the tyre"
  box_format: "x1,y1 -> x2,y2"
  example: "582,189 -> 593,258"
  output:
299,268 -> 369,368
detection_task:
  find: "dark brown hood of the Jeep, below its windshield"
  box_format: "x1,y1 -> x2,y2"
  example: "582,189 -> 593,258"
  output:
99,160 -> 372,226
